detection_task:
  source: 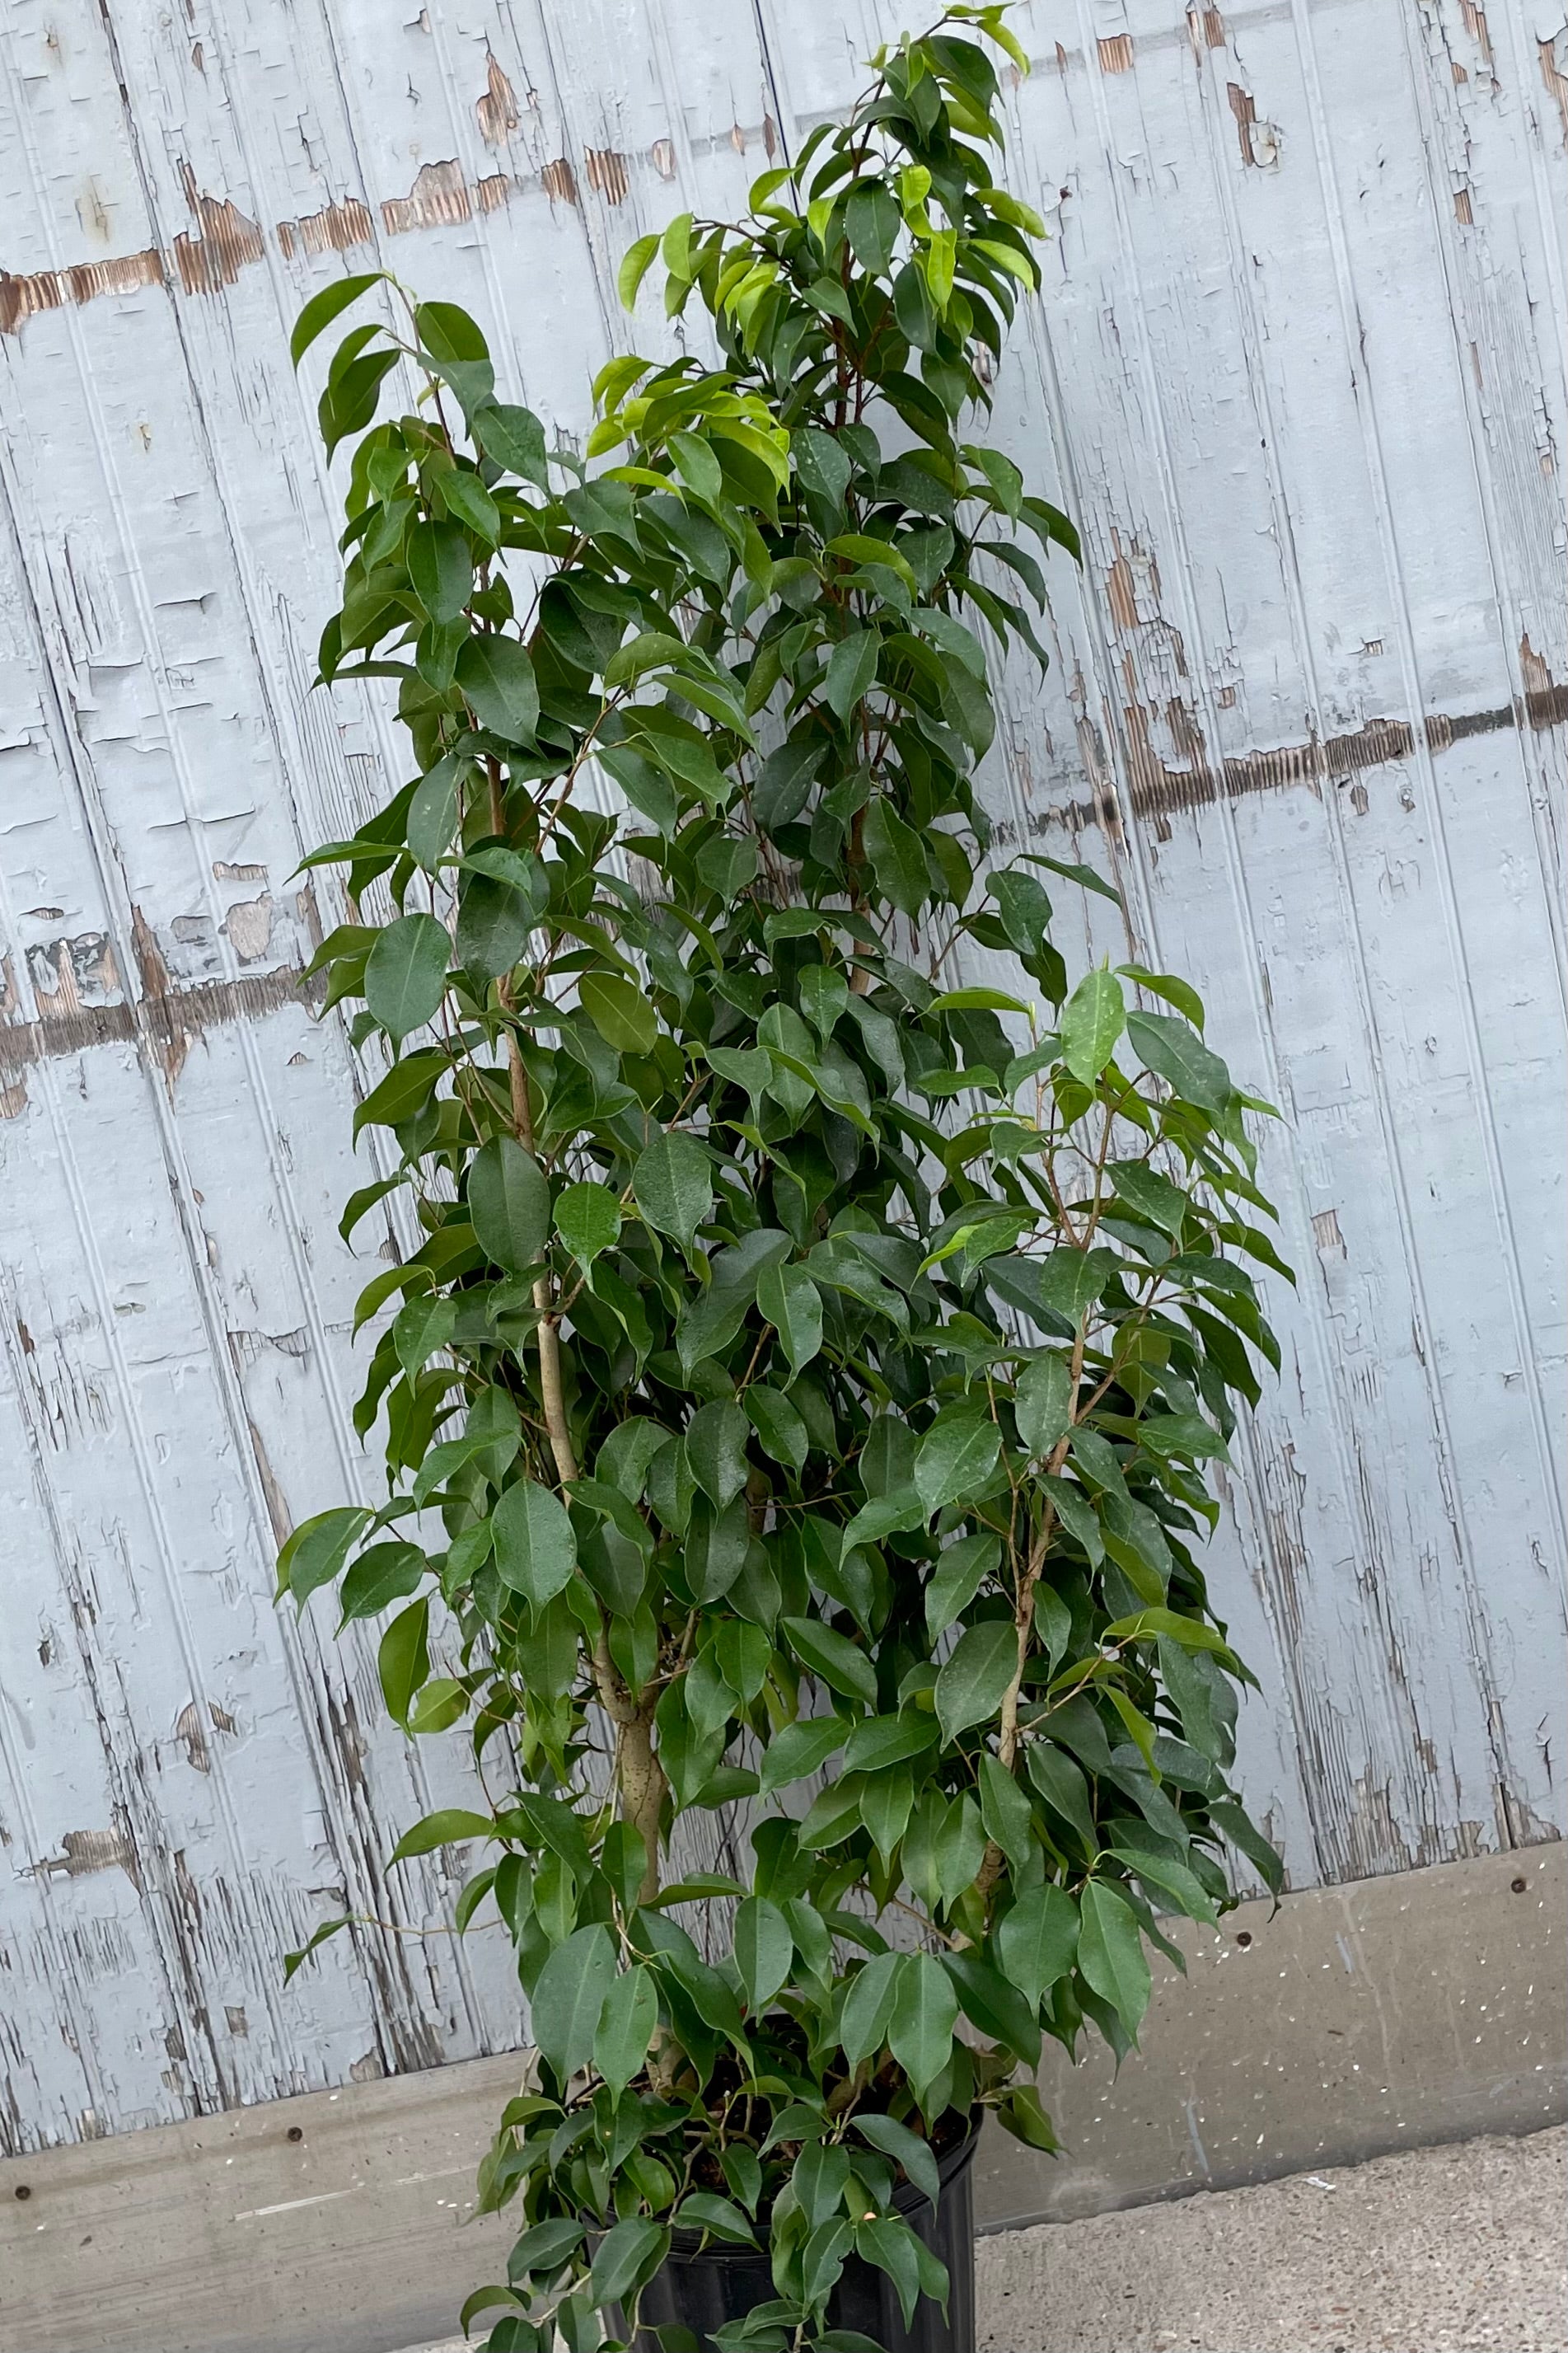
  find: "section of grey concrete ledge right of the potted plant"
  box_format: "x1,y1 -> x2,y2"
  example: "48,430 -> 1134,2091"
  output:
976,1842 -> 1568,2231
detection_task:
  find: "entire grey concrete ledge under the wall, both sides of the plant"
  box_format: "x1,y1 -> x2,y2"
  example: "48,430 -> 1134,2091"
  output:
0,1847 -> 1568,2353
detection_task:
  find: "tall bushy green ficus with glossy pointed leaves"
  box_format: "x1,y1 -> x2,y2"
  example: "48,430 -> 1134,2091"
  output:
280,7 -> 1286,2353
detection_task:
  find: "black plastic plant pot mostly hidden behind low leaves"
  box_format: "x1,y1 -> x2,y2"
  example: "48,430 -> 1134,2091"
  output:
637,2120 -> 981,2353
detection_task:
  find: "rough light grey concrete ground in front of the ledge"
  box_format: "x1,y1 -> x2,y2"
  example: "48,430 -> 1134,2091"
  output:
401,2127 -> 1568,2353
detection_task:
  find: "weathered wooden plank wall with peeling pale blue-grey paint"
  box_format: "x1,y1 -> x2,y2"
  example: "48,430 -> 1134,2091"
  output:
0,0 -> 1568,2149
